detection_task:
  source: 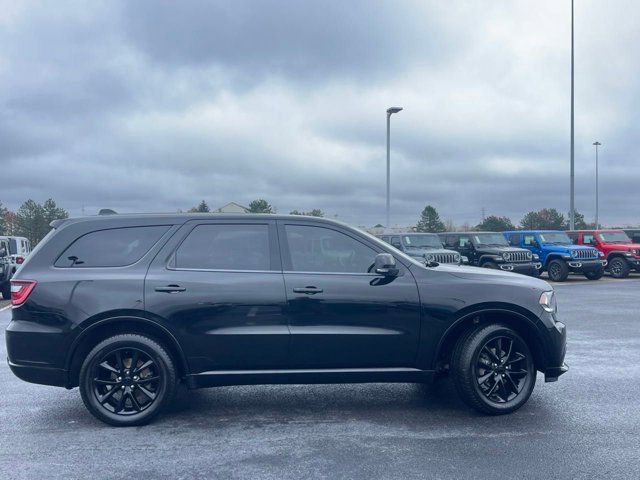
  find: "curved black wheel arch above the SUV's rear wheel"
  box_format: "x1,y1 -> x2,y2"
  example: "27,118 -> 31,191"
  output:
66,315 -> 189,388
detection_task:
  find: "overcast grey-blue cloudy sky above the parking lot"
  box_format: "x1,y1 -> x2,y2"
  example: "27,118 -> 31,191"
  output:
0,0 -> 640,225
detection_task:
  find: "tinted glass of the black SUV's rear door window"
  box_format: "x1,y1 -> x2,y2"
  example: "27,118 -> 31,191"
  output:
175,224 -> 271,270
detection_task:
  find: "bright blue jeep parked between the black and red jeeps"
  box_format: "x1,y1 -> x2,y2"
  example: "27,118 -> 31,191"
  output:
502,230 -> 607,282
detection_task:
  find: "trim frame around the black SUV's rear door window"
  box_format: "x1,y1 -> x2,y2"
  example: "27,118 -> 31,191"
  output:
165,220 -> 282,273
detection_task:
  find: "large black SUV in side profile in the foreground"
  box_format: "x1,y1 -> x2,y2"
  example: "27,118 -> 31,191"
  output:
6,214 -> 567,425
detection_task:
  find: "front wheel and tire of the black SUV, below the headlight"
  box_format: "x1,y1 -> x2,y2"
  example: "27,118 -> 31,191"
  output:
451,324 -> 536,415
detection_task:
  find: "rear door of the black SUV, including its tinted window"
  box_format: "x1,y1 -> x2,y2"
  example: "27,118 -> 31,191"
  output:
145,219 -> 289,373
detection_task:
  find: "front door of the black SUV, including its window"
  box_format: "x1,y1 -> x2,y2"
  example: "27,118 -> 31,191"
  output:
278,221 -> 420,368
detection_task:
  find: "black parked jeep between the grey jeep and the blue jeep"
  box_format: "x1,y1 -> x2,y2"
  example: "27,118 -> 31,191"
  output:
441,232 -> 542,277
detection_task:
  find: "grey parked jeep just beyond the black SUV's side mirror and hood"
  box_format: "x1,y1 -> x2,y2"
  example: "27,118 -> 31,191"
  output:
377,233 -> 464,265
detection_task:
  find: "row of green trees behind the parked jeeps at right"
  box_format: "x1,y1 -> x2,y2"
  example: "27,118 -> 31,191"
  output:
414,205 -> 595,233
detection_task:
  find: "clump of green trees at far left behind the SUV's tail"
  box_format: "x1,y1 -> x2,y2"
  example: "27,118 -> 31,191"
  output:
0,198 -> 69,246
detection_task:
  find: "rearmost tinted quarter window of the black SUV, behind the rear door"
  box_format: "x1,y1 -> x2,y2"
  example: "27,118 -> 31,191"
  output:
55,225 -> 170,268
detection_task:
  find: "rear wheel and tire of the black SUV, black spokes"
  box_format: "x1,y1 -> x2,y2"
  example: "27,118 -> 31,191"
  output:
79,333 -> 178,427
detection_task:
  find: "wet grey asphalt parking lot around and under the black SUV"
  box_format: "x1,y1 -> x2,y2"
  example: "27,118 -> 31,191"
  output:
0,278 -> 640,479
